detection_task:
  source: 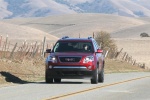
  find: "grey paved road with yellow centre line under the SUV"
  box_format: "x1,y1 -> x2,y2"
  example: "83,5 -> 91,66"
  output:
0,72 -> 150,100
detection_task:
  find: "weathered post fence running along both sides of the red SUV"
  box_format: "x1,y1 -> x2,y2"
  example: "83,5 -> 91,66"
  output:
0,36 -> 145,68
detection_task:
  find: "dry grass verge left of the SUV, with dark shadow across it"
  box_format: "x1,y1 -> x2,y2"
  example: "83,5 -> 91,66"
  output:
0,59 -> 45,83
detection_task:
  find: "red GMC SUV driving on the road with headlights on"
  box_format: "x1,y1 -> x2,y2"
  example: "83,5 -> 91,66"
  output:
45,36 -> 104,84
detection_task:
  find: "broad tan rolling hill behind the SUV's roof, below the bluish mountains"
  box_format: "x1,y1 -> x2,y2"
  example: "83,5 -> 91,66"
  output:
3,14 -> 146,37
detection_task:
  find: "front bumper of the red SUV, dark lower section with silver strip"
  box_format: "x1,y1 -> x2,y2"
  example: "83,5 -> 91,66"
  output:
46,66 -> 94,79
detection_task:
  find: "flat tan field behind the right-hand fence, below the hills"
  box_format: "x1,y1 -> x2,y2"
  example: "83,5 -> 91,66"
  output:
115,38 -> 150,68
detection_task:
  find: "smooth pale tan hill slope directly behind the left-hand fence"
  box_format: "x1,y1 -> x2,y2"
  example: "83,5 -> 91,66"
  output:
0,22 -> 58,43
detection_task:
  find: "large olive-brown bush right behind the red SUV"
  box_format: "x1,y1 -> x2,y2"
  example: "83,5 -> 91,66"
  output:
95,31 -> 117,58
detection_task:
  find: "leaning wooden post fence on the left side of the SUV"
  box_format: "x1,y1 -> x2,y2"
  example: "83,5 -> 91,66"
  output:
0,36 -> 53,60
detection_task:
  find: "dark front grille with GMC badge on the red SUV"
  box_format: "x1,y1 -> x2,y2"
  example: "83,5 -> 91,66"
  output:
59,57 -> 81,62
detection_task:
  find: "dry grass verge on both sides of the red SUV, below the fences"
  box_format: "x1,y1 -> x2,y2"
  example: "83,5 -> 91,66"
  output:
0,59 -> 148,85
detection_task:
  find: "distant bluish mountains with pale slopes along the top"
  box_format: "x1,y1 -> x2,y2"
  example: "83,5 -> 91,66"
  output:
0,0 -> 150,19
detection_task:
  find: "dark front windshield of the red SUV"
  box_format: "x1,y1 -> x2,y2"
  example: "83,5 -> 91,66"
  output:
53,41 -> 94,53
